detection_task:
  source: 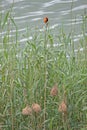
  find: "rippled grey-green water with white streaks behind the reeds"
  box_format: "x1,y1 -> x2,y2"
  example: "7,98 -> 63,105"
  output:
0,0 -> 87,46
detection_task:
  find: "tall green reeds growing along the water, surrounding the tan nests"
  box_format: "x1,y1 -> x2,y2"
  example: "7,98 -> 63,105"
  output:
0,9 -> 87,130
